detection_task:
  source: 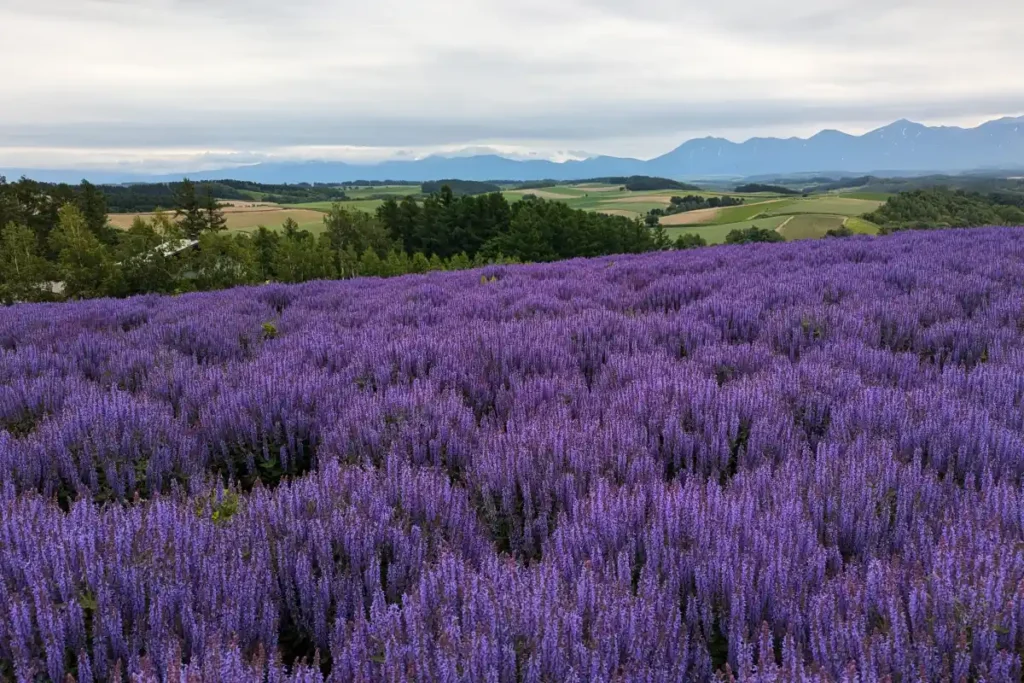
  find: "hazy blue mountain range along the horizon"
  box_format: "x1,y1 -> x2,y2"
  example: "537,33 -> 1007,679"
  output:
0,117 -> 1024,183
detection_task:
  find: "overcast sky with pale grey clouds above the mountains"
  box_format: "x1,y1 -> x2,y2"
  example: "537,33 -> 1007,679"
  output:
0,0 -> 1024,171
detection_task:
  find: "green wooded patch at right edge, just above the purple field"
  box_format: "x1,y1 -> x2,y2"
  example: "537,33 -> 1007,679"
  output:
864,187 -> 1024,232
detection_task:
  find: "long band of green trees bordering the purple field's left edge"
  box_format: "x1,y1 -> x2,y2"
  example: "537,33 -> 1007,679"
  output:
0,179 -> 671,303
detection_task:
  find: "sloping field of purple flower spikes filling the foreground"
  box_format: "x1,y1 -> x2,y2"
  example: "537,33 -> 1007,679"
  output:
0,228 -> 1024,683
